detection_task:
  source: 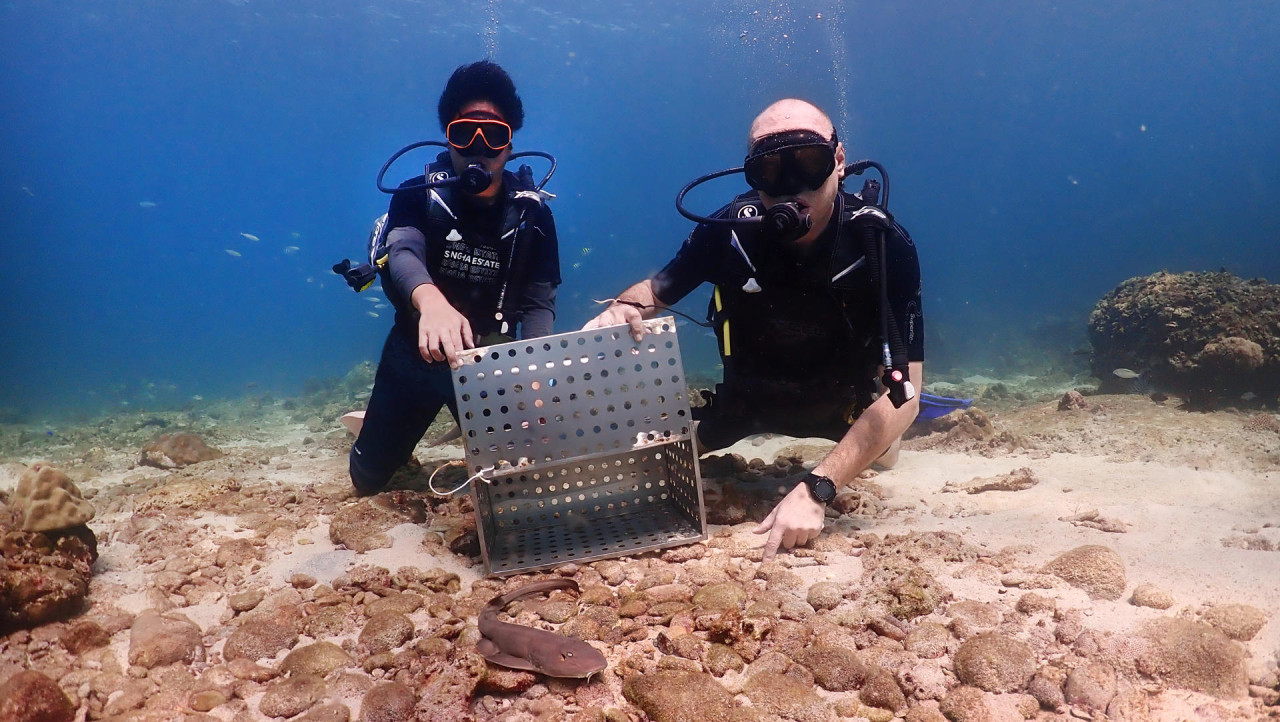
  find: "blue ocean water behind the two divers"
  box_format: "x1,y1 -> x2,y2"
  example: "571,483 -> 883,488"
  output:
0,0 -> 1280,416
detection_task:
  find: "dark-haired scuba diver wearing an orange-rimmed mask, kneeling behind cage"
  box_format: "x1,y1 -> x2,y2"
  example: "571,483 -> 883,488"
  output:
334,60 -> 561,494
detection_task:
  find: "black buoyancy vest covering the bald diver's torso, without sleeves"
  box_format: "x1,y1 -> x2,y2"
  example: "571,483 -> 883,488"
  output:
708,192 -> 909,422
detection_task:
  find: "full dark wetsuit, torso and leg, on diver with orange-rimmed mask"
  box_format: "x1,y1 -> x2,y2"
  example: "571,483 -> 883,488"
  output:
349,174 -> 561,494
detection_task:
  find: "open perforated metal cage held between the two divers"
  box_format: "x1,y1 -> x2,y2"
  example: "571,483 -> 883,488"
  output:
453,317 -> 707,575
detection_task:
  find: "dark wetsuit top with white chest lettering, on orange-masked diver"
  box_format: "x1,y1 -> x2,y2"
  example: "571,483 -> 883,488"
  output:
385,173 -> 561,344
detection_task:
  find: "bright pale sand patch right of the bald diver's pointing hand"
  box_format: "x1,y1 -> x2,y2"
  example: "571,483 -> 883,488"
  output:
870,452 -> 1280,681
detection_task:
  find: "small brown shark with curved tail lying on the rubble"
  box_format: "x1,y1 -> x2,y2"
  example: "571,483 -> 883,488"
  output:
476,579 -> 608,678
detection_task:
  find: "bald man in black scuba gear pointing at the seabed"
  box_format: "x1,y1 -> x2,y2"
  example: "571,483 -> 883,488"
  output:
585,99 -> 924,559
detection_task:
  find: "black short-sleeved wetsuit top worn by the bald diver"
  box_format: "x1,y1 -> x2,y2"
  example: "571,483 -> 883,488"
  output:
652,193 -> 924,437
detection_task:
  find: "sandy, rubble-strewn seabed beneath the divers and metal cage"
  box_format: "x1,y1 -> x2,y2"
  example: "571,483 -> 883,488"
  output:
0,396 -> 1280,721
